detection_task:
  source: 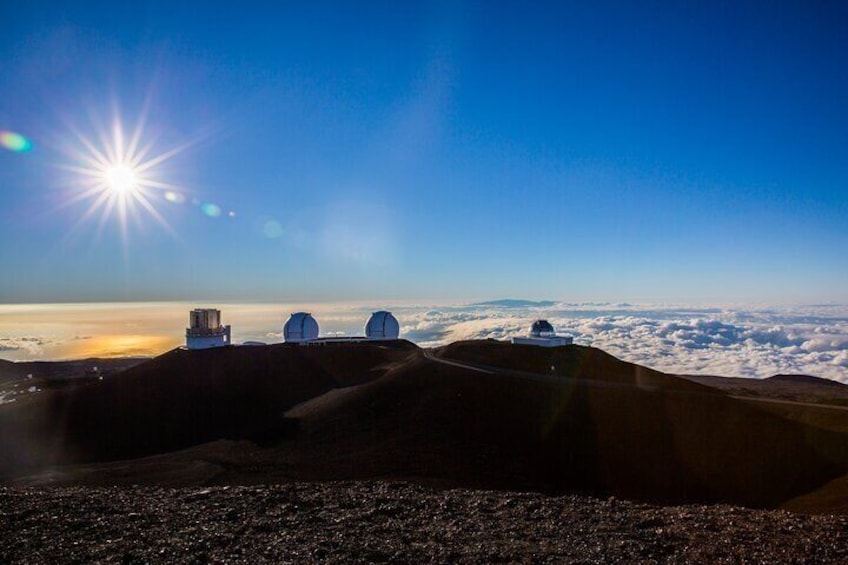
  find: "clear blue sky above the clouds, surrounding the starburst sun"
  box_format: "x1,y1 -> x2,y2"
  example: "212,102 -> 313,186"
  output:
0,2 -> 848,303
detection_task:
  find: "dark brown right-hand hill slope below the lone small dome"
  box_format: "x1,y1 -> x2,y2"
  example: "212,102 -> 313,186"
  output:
289,342 -> 848,507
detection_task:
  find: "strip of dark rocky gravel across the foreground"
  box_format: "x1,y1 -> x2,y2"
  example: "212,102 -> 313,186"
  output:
0,482 -> 848,563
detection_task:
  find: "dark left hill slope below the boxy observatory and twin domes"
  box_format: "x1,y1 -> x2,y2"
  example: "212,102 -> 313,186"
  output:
0,342 -> 415,475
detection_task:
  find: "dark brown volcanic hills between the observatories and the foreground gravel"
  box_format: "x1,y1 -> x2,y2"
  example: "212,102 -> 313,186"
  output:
0,341 -> 848,510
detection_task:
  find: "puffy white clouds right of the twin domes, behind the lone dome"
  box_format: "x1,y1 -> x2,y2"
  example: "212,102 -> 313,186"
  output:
384,301 -> 848,383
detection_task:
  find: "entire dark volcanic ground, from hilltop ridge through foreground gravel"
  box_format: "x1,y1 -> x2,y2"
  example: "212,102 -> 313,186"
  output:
0,341 -> 848,563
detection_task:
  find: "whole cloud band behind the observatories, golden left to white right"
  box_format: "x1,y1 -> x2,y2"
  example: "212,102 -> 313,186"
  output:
0,300 -> 848,384
